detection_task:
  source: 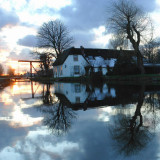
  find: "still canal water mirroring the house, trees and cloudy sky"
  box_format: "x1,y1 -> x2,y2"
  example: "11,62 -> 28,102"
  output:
0,82 -> 160,160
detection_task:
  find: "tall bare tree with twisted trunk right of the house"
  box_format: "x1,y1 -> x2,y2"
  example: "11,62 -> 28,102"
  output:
107,0 -> 152,73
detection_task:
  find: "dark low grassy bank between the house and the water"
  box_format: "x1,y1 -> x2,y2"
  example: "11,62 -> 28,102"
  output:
33,74 -> 160,84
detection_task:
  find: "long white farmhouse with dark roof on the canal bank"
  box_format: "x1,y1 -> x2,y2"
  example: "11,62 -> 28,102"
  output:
53,47 -> 133,77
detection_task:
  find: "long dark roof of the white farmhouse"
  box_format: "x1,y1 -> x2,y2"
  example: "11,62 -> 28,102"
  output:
53,47 -> 134,66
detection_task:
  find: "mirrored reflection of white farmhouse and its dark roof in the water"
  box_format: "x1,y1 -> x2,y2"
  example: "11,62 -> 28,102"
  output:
54,82 -> 142,110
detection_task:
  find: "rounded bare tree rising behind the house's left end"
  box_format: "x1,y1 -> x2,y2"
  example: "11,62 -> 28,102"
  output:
37,20 -> 73,58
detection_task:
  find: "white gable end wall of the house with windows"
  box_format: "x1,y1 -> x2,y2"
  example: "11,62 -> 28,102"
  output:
53,55 -> 88,77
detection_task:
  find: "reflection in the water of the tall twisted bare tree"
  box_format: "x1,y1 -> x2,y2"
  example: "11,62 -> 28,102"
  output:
110,85 -> 151,155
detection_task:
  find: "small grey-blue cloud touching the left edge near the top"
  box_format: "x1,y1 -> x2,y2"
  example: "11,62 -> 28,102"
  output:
0,8 -> 19,29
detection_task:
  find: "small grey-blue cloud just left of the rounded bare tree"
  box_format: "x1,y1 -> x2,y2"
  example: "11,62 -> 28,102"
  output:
17,35 -> 37,47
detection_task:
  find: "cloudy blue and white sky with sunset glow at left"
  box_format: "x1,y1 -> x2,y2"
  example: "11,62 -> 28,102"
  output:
0,0 -> 160,72
